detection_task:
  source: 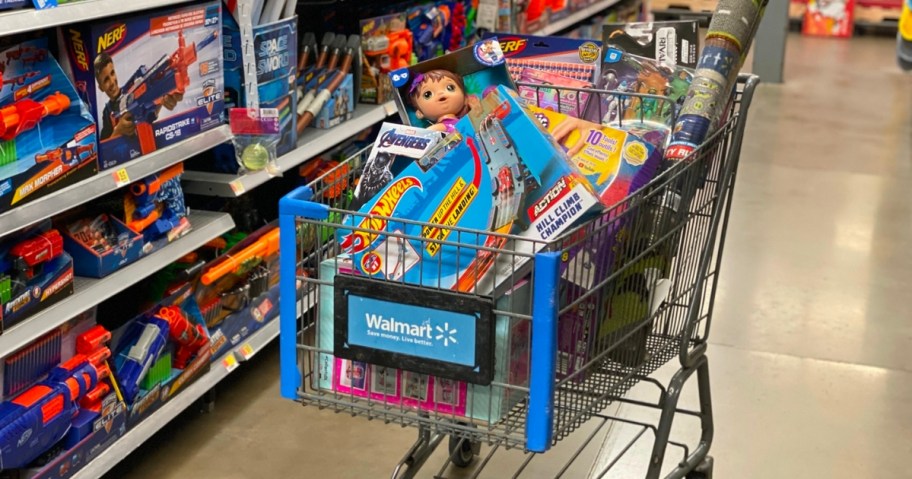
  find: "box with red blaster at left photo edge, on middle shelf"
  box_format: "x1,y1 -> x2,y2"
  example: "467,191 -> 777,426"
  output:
0,224 -> 73,329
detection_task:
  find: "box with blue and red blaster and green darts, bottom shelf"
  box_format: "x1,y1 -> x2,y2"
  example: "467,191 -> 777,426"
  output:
110,285 -> 212,428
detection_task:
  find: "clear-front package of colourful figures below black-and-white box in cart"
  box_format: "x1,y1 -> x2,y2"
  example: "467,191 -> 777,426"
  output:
586,48 -> 693,128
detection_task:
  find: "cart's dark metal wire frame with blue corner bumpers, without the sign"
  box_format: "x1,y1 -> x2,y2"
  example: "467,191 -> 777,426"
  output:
280,75 -> 758,478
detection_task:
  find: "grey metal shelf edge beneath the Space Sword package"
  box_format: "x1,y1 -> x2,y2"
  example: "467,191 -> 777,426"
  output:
181,102 -> 396,198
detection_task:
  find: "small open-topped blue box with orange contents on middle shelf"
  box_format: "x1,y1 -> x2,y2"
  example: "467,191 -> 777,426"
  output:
63,214 -> 143,278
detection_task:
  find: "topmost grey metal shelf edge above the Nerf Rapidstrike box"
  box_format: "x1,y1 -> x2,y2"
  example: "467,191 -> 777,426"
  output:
0,0 -> 199,35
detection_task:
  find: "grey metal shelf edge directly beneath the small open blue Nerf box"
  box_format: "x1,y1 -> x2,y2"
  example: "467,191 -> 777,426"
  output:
0,211 -> 234,354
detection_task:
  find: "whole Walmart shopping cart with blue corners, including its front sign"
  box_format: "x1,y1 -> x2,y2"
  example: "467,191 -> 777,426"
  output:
280,75 -> 758,478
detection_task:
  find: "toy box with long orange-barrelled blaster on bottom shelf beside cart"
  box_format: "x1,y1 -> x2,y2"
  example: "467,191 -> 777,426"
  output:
194,224 -> 279,358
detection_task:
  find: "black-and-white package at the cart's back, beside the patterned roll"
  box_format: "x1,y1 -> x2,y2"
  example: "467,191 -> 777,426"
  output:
602,20 -> 700,68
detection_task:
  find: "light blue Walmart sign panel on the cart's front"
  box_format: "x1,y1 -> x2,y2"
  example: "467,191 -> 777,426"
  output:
348,295 -> 478,366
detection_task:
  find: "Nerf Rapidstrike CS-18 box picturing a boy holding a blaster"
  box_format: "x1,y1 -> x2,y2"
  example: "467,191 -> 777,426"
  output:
62,2 -> 224,169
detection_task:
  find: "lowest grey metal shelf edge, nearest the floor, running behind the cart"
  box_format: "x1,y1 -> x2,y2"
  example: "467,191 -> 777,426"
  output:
73,318 -> 279,479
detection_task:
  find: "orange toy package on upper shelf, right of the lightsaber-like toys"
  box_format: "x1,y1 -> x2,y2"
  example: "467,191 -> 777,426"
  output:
359,13 -> 413,104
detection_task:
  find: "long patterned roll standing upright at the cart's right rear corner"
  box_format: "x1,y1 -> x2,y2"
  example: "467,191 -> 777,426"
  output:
665,0 -> 766,162
